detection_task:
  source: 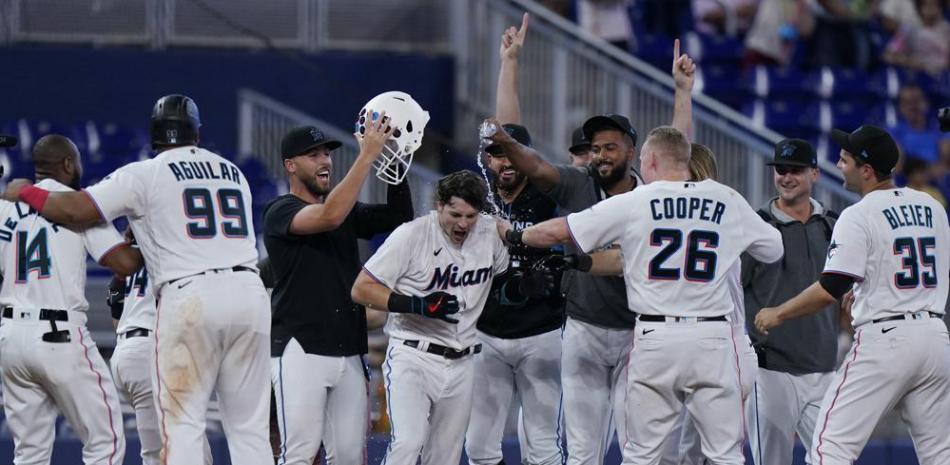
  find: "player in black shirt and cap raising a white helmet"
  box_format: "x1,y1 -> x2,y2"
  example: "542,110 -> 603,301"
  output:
264,113 -> 416,465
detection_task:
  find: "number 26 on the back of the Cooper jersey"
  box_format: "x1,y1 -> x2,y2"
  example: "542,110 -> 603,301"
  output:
648,228 -> 719,282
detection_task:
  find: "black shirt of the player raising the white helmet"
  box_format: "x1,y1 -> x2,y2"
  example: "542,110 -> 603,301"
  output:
264,183 -> 412,357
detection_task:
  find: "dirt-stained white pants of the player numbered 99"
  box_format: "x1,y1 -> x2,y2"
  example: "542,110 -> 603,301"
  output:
153,270 -> 274,465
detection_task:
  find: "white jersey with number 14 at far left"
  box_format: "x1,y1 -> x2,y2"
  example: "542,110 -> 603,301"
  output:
0,179 -> 125,311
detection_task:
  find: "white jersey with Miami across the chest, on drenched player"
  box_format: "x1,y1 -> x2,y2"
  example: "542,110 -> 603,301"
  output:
363,211 -> 508,350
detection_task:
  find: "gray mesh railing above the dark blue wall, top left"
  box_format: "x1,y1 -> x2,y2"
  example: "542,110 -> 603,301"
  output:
0,0 -> 454,52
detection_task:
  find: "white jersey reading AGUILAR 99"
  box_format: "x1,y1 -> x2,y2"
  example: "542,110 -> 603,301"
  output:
86,146 -> 257,291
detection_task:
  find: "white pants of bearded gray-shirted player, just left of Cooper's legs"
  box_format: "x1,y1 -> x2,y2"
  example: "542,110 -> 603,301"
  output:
561,317 -> 633,465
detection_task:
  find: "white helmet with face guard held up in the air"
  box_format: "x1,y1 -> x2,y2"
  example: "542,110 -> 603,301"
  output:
356,91 -> 429,184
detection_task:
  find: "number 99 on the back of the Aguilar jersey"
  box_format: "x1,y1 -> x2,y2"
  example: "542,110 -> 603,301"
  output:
182,188 -> 248,239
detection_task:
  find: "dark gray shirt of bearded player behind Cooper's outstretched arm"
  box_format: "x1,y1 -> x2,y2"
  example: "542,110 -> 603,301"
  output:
547,165 -> 641,328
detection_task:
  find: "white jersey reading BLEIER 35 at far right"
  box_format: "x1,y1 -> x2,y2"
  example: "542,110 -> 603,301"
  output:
824,188 -> 950,327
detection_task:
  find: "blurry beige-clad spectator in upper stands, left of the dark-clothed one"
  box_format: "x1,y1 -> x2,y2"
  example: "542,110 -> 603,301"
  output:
743,0 -> 814,68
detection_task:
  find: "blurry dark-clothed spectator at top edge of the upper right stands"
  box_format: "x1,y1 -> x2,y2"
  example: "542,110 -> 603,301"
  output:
806,0 -> 872,69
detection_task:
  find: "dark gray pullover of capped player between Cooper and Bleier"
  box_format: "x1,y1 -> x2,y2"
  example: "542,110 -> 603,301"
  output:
742,199 -> 838,374
